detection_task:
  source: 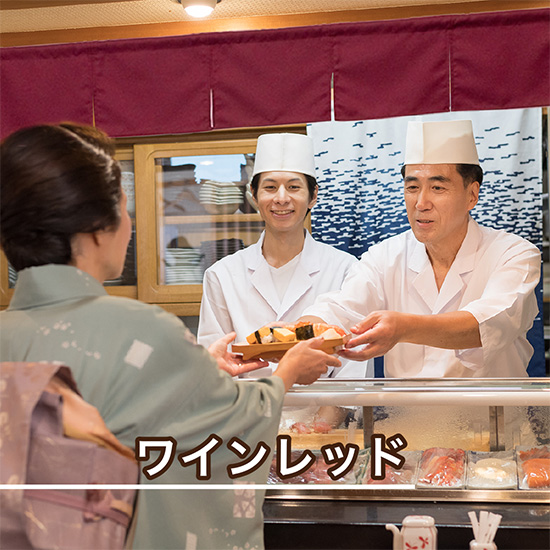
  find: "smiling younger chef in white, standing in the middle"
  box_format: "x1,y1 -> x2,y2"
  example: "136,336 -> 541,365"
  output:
198,133 -> 367,378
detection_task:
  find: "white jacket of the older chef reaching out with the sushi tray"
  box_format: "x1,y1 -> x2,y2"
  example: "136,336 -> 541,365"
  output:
304,218 -> 541,377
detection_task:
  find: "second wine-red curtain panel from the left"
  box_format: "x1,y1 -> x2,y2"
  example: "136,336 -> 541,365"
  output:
94,37 -> 210,137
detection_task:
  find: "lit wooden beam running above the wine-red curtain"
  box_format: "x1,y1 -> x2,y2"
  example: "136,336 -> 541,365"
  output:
0,0 -> 550,47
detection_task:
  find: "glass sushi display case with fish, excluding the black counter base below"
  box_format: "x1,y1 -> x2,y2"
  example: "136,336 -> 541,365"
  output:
268,378 -> 550,502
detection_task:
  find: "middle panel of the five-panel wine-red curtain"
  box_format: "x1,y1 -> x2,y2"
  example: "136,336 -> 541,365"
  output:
212,27 -> 331,128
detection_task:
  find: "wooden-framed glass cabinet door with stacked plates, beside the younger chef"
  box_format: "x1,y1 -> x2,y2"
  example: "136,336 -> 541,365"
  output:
134,136 -> 263,315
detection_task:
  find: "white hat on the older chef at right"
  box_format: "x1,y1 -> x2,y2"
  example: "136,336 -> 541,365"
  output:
405,120 -> 479,166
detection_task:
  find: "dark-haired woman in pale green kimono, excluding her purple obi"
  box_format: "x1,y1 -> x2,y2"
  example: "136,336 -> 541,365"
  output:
0,124 -> 340,550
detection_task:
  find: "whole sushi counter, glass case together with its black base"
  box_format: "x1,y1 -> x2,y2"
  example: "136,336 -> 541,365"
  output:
264,378 -> 550,550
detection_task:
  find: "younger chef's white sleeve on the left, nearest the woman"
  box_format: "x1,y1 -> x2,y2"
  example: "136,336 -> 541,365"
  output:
197,269 -> 234,347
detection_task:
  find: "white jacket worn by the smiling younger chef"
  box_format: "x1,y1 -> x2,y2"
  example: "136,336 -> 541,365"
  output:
198,231 -> 374,378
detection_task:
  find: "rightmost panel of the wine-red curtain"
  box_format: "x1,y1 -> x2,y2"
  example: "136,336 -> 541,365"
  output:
451,9 -> 550,111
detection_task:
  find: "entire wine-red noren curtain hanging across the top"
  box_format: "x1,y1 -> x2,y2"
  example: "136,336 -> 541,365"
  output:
0,9 -> 550,140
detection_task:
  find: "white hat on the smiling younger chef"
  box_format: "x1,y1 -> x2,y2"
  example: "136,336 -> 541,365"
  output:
252,134 -> 315,177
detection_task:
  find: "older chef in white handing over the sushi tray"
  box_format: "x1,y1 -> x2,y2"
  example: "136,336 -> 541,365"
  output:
304,120 -> 541,377
